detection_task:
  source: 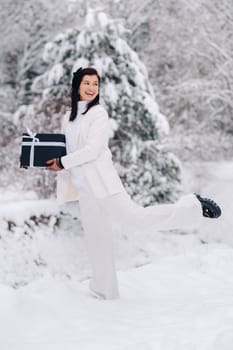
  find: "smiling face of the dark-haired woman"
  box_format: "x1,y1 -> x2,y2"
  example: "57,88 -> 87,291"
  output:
79,75 -> 99,101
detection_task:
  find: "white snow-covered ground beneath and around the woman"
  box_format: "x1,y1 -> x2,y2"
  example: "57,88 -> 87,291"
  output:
0,162 -> 233,350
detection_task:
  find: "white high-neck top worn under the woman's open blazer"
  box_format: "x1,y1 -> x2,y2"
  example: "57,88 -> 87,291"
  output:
65,101 -> 88,189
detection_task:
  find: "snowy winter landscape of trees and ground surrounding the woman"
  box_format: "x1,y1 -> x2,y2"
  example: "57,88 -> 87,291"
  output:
0,0 -> 233,350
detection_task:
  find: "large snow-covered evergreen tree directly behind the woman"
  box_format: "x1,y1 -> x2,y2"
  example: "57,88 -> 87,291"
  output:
16,10 -> 180,205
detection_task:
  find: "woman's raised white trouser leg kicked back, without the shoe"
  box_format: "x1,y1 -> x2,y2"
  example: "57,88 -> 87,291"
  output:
100,192 -> 202,230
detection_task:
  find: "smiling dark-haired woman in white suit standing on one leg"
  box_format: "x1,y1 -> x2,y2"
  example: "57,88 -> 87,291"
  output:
47,68 -> 221,299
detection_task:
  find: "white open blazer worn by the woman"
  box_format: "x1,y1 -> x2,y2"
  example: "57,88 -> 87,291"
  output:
57,105 -> 125,203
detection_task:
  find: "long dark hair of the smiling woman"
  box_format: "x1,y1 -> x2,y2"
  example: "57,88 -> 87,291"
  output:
69,67 -> 100,121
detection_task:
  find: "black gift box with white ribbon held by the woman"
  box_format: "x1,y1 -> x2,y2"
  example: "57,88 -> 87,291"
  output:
20,132 -> 66,168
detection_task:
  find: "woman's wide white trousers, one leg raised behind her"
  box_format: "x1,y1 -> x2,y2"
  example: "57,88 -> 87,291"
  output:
75,174 -> 202,299
